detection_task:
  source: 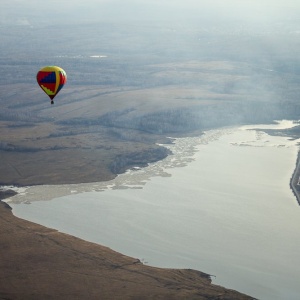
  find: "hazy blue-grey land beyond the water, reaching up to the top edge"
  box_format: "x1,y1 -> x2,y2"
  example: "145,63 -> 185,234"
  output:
0,0 -> 300,295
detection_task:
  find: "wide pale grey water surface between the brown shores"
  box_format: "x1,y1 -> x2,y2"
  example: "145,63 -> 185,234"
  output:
8,121 -> 300,300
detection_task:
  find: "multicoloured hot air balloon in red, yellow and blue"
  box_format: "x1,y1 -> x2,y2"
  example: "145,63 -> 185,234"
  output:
36,66 -> 67,104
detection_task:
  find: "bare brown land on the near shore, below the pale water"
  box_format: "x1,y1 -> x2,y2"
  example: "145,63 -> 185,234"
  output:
0,195 -> 254,300
